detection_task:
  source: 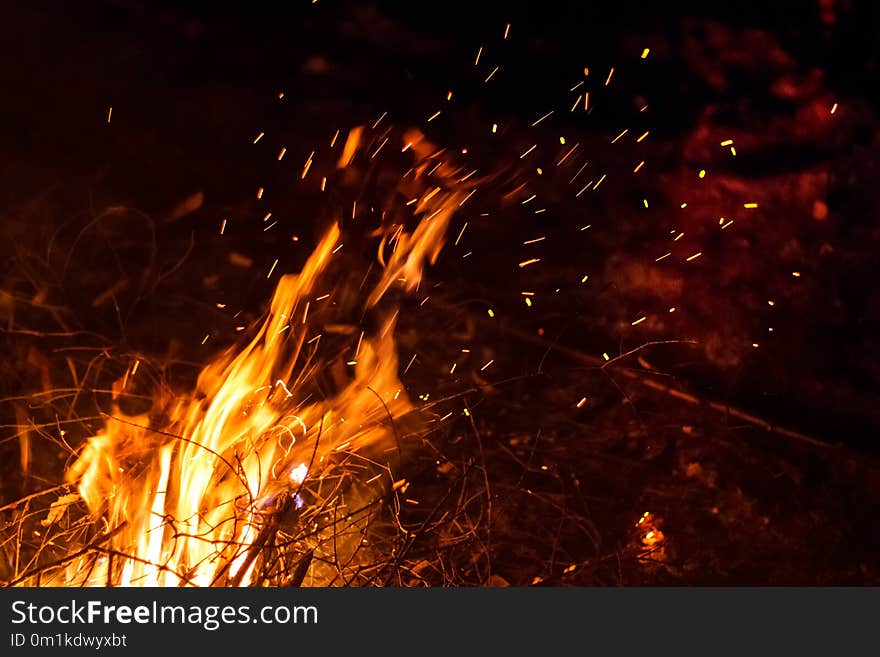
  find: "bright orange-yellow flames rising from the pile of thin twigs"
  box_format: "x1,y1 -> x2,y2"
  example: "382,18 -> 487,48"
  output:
42,128 -> 466,586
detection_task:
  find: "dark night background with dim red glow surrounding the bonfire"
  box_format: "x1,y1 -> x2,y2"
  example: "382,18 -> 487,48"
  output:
0,0 -> 880,584
